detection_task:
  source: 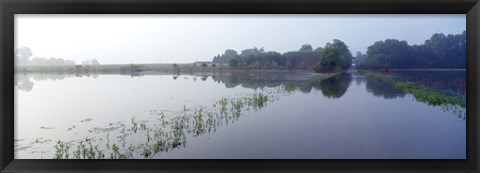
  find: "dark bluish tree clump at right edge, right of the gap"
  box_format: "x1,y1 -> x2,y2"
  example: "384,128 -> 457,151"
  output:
355,31 -> 466,69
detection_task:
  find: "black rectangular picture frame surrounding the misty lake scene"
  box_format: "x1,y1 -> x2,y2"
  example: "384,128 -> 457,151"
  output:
0,0 -> 480,172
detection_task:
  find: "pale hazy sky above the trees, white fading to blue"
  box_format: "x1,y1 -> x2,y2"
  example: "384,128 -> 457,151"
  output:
15,14 -> 466,64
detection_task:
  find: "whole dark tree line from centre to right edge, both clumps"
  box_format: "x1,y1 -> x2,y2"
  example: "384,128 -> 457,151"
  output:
212,31 -> 466,72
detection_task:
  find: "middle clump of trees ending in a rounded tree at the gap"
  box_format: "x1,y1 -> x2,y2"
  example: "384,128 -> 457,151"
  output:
212,39 -> 352,72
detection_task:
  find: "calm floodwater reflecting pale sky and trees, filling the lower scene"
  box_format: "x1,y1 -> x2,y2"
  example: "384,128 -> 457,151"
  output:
15,72 -> 466,159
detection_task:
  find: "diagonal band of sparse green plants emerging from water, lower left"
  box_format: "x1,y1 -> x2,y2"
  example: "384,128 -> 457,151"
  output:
47,90 -> 275,159
